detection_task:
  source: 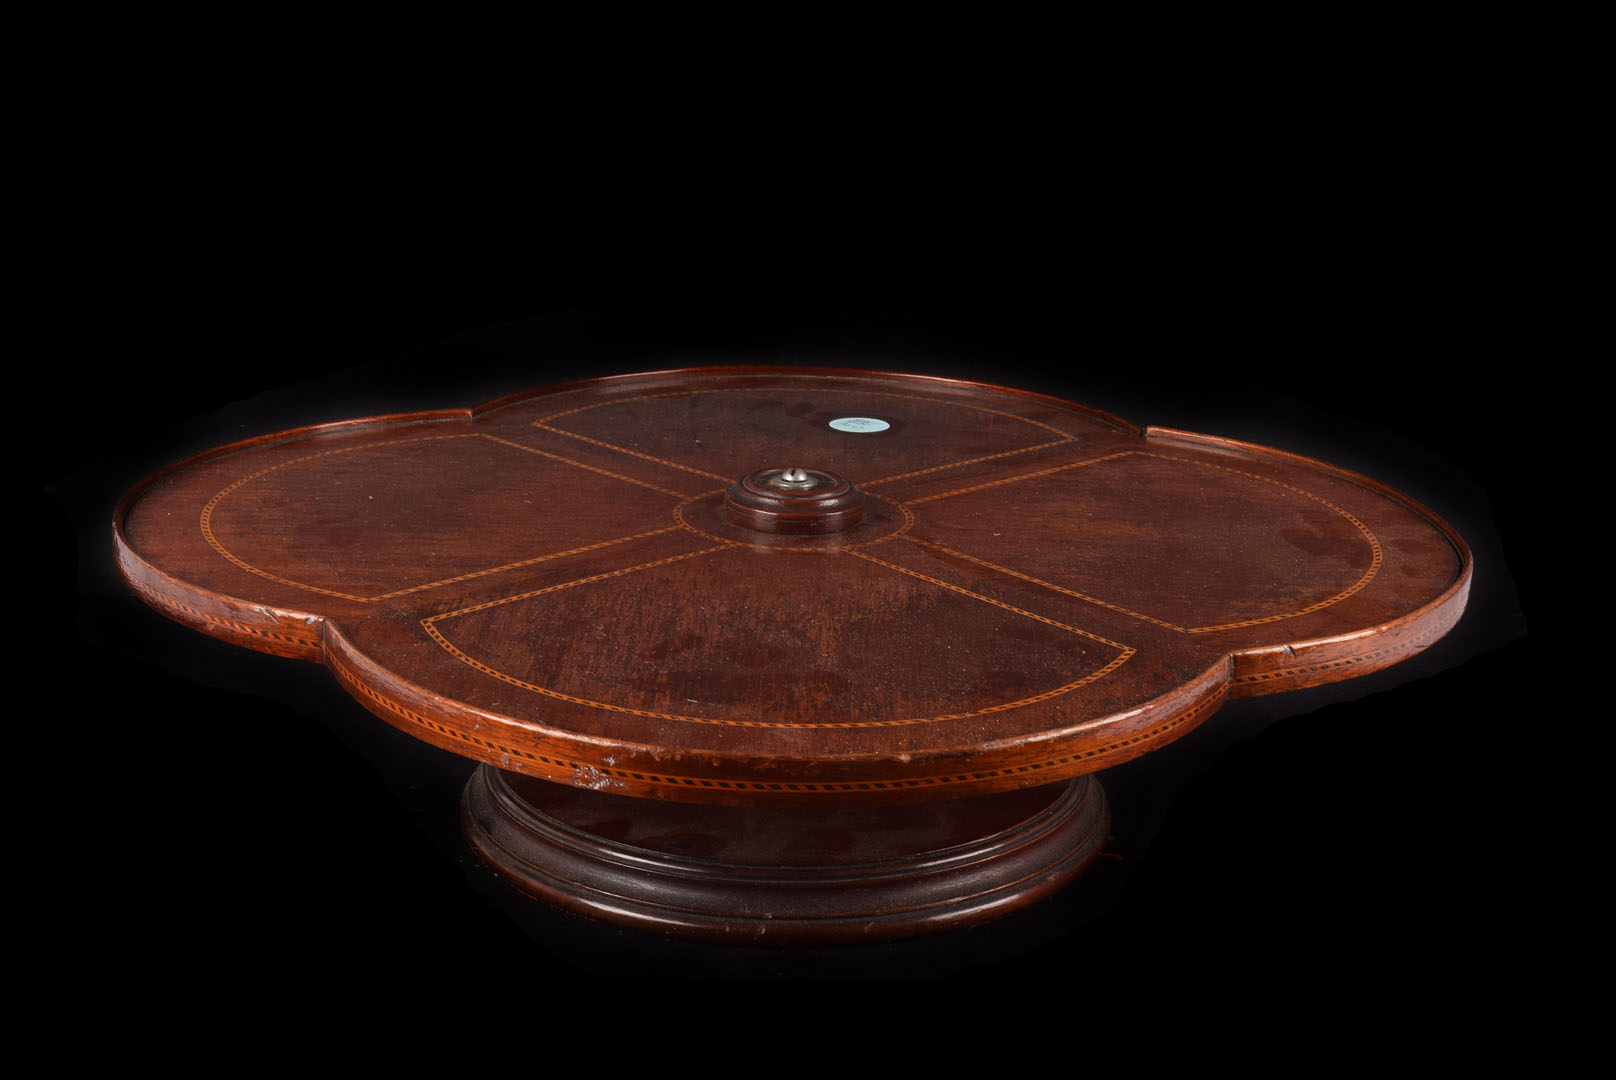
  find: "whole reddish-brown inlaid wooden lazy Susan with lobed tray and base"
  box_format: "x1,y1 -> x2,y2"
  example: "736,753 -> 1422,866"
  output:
113,367 -> 1471,943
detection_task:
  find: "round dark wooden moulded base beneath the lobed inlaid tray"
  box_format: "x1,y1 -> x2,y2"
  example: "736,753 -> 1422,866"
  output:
461,765 -> 1110,944
